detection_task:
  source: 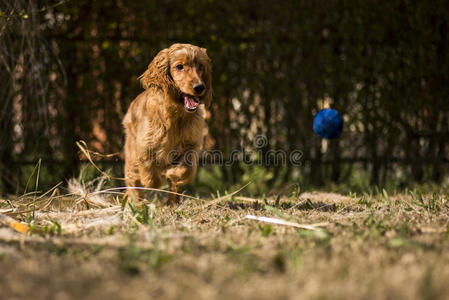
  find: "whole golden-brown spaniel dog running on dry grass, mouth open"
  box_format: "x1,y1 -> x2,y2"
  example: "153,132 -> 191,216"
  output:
123,44 -> 212,204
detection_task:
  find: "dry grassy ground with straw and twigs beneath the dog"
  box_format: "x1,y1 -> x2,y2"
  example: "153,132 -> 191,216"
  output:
0,188 -> 449,300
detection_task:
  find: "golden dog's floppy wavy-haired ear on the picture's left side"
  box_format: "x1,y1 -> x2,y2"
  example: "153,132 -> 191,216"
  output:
139,49 -> 173,90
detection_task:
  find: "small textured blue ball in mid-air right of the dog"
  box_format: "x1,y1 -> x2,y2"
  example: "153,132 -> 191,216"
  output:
313,108 -> 343,139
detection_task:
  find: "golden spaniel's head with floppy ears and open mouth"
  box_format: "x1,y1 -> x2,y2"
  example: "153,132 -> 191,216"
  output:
139,44 -> 213,112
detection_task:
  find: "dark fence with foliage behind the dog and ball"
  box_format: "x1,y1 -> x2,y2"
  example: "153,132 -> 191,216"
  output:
0,0 -> 449,192
